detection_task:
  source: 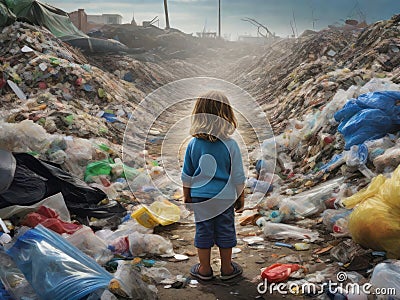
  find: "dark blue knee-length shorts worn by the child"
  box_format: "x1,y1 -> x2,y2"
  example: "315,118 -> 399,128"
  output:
192,197 -> 237,249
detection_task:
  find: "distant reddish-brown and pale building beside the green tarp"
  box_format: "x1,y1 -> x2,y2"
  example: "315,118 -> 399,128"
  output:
68,8 -> 122,33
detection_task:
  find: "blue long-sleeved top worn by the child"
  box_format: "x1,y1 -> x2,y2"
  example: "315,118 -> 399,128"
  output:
182,138 -> 246,199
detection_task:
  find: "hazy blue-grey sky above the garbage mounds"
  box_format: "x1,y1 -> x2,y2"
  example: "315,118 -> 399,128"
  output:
43,0 -> 400,39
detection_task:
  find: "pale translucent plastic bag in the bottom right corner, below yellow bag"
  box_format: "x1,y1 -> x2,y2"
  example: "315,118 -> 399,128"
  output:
370,260 -> 400,299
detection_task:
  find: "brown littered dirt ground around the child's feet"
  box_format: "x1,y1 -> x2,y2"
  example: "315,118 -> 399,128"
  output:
152,215 -> 326,300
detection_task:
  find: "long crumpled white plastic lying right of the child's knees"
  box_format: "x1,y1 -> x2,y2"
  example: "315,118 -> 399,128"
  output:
256,218 -> 319,242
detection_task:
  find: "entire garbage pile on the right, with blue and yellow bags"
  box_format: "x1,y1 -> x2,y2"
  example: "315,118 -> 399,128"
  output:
228,15 -> 400,299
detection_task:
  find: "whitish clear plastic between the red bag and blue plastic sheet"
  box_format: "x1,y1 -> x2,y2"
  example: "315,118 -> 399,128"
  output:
65,226 -> 114,265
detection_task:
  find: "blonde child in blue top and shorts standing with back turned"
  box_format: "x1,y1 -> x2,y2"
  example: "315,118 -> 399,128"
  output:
182,91 -> 246,280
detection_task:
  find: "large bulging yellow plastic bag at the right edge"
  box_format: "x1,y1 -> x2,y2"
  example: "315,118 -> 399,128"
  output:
343,166 -> 400,258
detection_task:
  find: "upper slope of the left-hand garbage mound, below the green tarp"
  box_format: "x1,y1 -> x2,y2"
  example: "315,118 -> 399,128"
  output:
0,22 -> 203,143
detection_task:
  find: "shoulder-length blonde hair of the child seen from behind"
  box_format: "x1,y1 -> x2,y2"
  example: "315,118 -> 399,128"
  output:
190,91 -> 237,142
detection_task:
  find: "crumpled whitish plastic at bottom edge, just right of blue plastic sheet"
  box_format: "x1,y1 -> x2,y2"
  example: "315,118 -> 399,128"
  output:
108,260 -> 157,300
